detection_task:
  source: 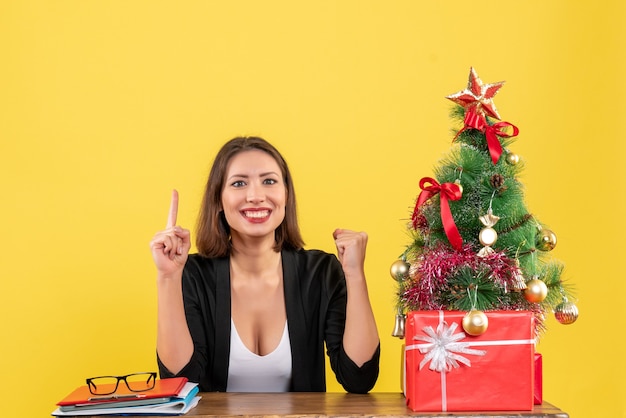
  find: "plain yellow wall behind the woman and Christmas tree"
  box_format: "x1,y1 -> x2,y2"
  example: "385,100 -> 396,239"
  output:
0,0 -> 626,418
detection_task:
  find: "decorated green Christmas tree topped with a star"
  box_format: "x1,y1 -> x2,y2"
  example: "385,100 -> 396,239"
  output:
391,68 -> 578,338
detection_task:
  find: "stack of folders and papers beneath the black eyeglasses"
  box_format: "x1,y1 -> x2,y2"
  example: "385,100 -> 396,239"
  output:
52,377 -> 200,416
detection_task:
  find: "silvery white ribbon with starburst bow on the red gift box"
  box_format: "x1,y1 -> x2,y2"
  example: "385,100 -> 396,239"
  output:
405,311 -> 535,412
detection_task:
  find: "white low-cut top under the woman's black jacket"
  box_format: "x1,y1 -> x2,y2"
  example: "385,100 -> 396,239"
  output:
226,318 -> 291,392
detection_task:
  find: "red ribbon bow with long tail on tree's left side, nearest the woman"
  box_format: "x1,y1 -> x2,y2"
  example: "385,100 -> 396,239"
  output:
413,177 -> 463,250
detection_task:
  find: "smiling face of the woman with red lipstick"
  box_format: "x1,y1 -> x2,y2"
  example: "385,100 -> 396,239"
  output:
222,150 -> 287,239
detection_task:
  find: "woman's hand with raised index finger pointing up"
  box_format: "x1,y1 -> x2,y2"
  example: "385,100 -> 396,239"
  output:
150,190 -> 191,278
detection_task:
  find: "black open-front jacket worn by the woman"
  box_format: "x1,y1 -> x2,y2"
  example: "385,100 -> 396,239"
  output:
157,250 -> 380,393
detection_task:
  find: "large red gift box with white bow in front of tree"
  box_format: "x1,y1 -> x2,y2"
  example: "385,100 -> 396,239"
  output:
404,311 -> 535,412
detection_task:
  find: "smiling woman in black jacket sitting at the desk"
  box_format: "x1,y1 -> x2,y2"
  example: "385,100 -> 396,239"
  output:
150,137 -> 380,393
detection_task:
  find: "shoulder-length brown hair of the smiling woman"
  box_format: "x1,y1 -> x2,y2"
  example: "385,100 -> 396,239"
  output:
196,136 -> 304,257
